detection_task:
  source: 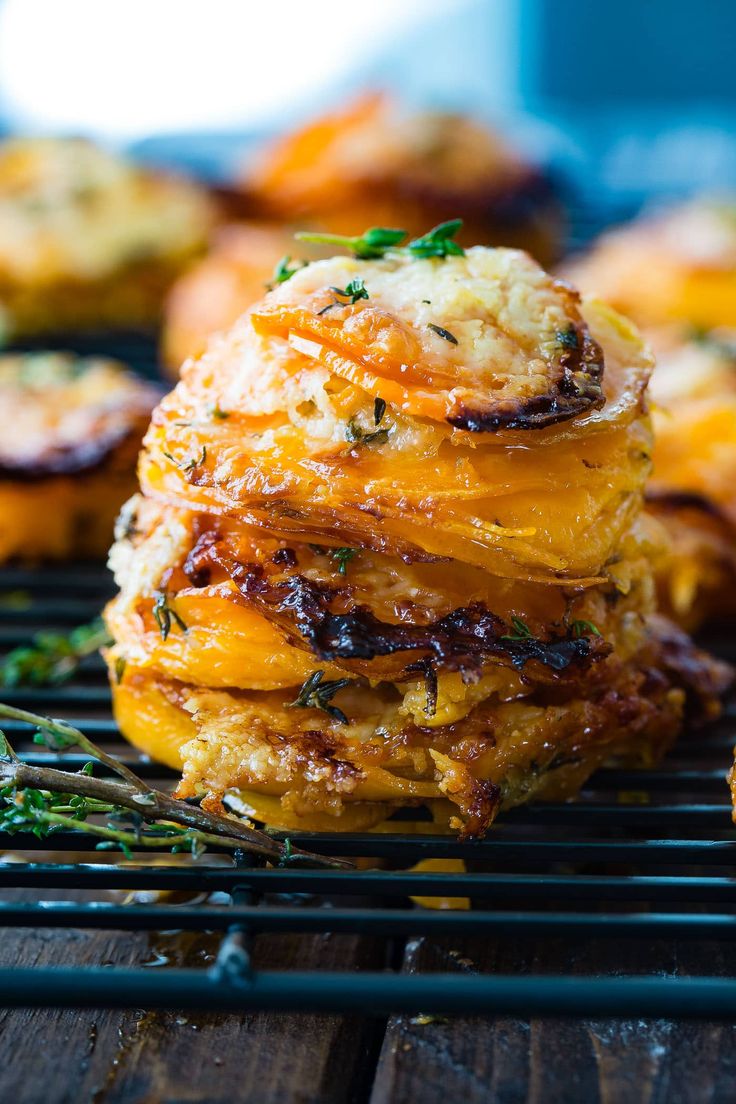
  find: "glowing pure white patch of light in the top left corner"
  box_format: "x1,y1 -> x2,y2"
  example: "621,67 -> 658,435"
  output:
0,0 -> 456,141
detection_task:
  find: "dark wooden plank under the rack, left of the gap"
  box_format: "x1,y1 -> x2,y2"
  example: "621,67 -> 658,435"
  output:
0,892 -> 385,1104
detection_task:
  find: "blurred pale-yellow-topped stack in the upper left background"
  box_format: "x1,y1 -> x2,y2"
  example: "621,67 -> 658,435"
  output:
0,138 -> 214,338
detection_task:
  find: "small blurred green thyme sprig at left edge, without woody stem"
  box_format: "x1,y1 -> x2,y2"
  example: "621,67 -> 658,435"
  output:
0,617 -> 111,687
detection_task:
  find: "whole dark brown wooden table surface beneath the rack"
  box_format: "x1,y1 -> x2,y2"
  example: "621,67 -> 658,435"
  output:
0,892 -> 736,1104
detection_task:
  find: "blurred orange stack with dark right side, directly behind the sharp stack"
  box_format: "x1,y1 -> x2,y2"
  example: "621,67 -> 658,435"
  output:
242,94 -> 562,264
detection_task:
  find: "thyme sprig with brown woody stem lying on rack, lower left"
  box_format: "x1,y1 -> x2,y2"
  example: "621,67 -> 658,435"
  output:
0,703 -> 349,867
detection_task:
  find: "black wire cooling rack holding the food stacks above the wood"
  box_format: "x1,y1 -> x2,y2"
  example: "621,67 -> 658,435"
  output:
0,565 -> 736,1019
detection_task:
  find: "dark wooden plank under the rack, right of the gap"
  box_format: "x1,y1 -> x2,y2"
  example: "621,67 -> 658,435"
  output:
371,940 -> 736,1104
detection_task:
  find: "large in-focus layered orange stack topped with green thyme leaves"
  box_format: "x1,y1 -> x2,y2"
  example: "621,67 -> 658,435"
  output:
106,235 -> 726,837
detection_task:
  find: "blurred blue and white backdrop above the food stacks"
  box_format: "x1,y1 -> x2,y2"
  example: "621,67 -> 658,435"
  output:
0,0 -> 736,209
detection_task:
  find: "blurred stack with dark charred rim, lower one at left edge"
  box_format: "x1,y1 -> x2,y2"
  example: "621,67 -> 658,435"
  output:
0,352 -> 161,562
